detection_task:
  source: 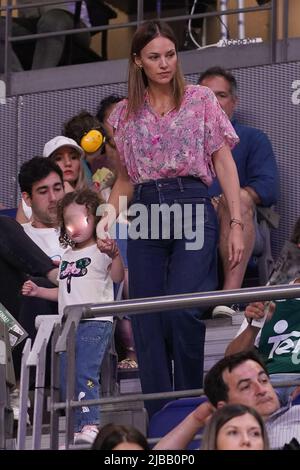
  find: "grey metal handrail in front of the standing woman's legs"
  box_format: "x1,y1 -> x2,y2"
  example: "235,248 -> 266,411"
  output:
44,285 -> 300,448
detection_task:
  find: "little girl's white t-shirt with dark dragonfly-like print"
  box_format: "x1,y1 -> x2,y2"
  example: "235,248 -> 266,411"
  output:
58,243 -> 114,322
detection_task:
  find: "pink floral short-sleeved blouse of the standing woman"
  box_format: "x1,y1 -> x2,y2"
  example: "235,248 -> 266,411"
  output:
109,85 -> 239,186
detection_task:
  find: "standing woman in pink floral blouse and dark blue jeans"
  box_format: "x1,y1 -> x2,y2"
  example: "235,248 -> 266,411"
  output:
98,21 -> 244,415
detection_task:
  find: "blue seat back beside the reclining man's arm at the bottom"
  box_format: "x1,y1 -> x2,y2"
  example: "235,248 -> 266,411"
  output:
148,396 -> 207,450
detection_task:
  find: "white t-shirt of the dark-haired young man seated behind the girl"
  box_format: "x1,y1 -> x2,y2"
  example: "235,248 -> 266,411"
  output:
22,222 -> 66,261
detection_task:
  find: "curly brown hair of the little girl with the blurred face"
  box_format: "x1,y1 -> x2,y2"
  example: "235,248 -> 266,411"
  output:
58,189 -> 104,248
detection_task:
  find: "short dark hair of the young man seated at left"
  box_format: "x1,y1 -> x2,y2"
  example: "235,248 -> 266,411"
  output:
18,157 -> 64,196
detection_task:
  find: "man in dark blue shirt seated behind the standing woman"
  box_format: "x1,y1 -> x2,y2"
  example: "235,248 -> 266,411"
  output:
198,67 -> 279,306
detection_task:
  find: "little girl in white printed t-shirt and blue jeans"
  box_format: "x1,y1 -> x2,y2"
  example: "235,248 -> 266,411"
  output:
22,190 -> 124,443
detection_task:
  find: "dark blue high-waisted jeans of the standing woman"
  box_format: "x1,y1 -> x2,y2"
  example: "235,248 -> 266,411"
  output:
127,177 -> 218,416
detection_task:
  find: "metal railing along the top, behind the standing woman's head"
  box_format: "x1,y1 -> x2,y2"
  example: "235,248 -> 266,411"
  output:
0,0 -> 280,95
